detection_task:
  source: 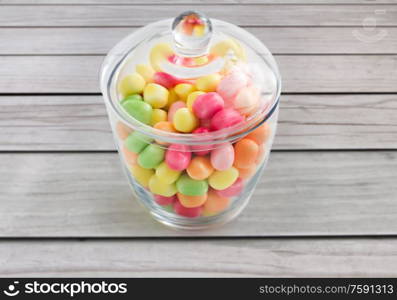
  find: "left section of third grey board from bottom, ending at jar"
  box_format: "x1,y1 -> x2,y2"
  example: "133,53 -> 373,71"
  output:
0,96 -> 115,151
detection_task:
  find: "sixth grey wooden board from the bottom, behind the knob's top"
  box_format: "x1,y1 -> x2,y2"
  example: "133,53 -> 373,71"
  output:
0,4 -> 397,27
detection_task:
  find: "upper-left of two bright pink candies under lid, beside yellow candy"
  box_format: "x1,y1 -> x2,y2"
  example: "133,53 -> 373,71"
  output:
193,92 -> 224,119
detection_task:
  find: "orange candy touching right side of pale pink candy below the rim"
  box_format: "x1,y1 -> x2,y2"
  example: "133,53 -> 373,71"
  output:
234,139 -> 259,169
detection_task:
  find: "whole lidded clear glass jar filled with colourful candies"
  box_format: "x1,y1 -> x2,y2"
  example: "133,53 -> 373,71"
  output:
101,11 -> 281,229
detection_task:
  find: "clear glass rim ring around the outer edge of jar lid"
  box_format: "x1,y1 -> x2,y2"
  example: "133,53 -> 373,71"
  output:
100,19 -> 281,145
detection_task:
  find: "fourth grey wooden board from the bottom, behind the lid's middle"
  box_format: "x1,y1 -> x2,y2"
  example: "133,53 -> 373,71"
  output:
0,55 -> 397,94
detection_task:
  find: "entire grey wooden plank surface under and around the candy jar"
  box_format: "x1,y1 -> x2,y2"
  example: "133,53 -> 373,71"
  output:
0,0 -> 397,277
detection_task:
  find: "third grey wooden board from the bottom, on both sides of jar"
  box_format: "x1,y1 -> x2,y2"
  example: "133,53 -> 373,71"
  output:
0,95 -> 397,151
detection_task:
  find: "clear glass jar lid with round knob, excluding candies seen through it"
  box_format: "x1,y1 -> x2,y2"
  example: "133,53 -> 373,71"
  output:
101,11 -> 281,145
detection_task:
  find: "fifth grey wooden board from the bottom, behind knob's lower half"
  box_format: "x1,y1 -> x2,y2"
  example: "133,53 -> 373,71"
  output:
0,27 -> 397,55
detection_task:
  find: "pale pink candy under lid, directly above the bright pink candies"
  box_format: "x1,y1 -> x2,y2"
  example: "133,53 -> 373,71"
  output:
216,70 -> 248,107
